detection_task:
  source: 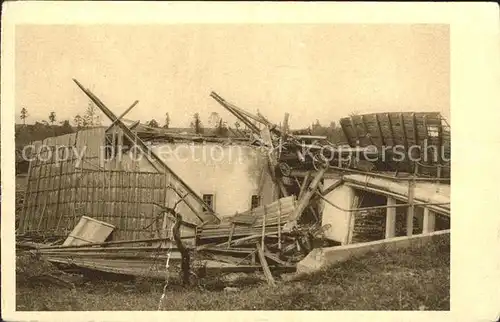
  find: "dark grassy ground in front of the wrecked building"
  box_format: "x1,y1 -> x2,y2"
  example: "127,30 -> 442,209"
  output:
16,238 -> 450,311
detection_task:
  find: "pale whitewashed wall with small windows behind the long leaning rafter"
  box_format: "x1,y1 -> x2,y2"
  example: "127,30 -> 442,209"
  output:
129,143 -> 274,216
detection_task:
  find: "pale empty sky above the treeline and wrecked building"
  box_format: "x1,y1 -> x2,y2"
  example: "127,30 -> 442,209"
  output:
15,24 -> 450,128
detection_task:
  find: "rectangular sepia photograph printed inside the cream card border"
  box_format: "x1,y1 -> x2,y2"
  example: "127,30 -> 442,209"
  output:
2,0 -> 500,320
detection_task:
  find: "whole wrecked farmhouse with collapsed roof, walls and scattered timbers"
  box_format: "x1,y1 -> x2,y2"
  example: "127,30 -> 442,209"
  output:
16,80 -> 450,284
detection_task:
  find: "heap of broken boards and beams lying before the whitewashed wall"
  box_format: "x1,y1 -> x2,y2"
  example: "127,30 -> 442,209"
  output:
18,196 -> 336,283
